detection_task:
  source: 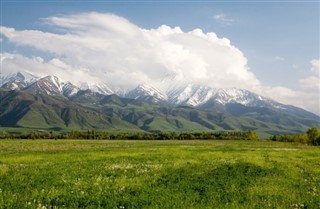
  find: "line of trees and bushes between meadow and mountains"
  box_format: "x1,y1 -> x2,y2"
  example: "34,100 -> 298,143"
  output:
0,127 -> 320,146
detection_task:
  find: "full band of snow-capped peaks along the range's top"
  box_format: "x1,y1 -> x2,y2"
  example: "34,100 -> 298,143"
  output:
2,72 -> 288,109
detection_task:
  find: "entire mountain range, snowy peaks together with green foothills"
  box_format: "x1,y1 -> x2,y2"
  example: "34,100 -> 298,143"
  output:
0,72 -> 320,135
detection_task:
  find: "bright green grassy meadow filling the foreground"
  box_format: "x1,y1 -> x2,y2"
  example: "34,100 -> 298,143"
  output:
0,140 -> 320,209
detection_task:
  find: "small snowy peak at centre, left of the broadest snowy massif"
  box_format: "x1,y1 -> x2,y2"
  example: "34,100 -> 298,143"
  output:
125,84 -> 167,103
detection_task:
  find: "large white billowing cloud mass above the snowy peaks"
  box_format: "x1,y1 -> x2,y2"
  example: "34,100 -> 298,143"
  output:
1,12 -> 320,112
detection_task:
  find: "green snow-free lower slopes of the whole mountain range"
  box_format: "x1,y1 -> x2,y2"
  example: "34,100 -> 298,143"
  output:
0,89 -> 320,134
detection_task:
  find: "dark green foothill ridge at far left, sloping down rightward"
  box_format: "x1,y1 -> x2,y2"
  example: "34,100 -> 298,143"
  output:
0,90 -> 135,130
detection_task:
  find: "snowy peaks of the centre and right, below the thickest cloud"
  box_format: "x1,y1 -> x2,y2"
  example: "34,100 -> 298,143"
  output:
125,84 -> 278,108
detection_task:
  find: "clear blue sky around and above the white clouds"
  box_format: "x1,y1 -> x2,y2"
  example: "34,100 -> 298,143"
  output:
1,0 -> 320,112
